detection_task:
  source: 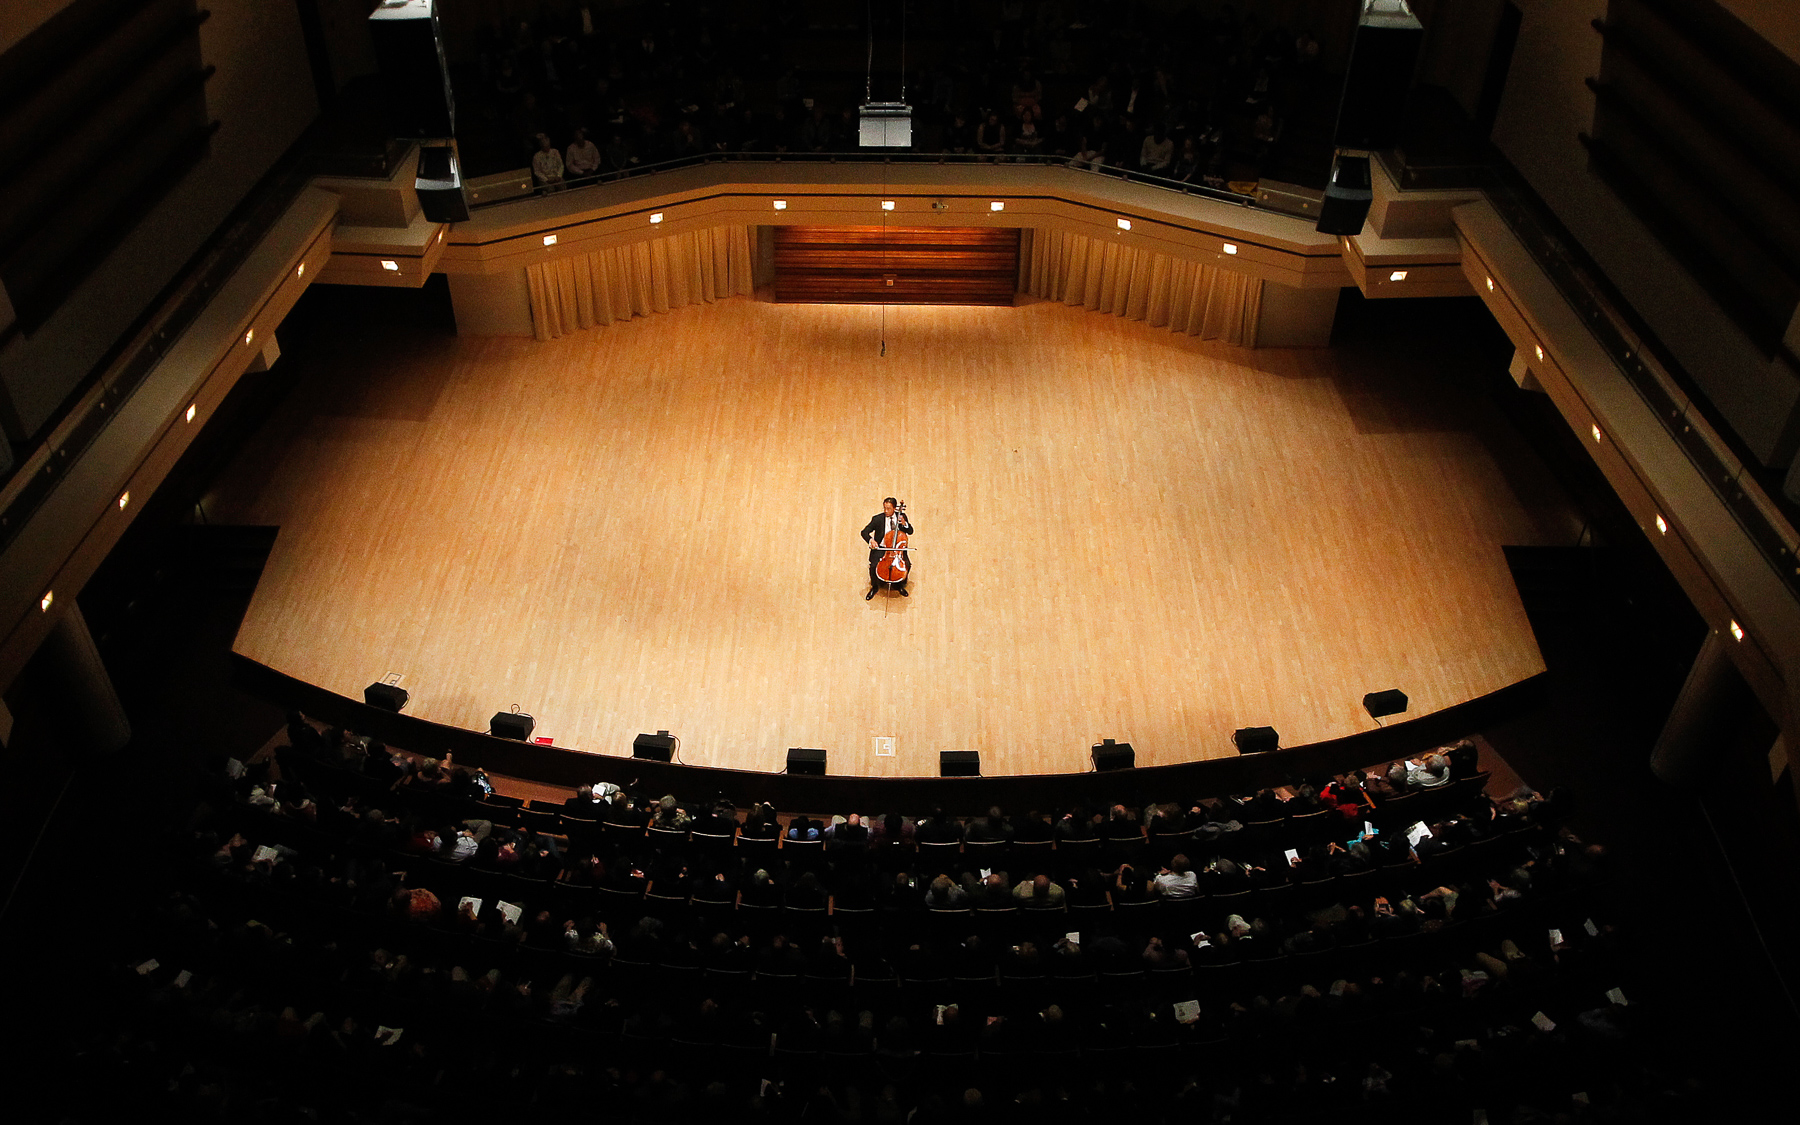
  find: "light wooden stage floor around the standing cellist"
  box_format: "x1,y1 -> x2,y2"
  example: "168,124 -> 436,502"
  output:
228,299 -> 1571,776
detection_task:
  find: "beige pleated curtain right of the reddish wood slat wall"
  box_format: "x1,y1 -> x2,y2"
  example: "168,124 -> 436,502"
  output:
1024,230 -> 1262,347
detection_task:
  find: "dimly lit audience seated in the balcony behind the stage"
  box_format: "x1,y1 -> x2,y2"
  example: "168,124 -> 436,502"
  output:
450,0 -> 1328,191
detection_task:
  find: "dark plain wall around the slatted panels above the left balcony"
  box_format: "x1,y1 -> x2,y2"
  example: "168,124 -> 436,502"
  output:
0,0 -> 319,464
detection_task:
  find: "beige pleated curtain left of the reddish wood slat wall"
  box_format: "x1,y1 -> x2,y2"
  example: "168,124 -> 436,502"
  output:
526,227 -> 756,340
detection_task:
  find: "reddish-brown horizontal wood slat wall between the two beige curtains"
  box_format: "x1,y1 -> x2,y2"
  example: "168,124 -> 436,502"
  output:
776,227 -> 1019,304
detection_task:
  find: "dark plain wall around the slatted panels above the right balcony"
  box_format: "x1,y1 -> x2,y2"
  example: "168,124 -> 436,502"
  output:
1471,0 -> 1800,499
